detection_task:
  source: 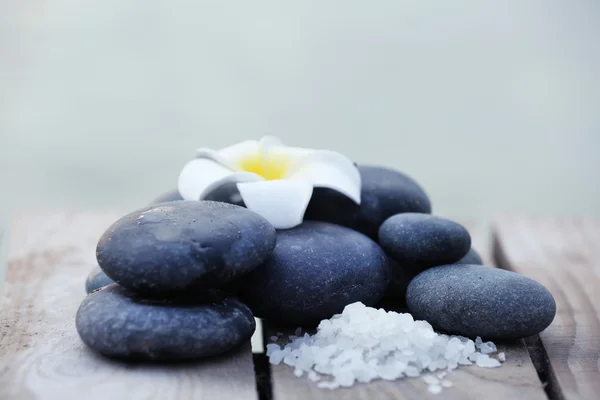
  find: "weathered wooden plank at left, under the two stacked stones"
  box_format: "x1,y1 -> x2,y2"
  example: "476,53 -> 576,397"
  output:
0,213 -> 257,400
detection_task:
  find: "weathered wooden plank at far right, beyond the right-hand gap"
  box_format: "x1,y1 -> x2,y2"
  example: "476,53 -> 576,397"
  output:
495,218 -> 600,400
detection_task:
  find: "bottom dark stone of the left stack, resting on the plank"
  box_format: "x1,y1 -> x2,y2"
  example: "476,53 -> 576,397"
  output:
75,284 -> 256,361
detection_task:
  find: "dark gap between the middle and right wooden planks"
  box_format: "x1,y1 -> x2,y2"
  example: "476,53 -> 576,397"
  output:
492,230 -> 565,400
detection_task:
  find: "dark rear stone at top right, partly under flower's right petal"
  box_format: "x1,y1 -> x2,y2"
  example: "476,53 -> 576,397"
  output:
304,165 -> 431,239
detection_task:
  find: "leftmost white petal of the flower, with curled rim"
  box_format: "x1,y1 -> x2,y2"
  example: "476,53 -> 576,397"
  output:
177,158 -> 263,200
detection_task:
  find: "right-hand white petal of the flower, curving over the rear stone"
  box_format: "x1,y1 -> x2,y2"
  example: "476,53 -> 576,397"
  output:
285,150 -> 361,204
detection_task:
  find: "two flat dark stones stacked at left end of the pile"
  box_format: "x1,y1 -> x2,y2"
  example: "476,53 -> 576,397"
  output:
76,201 -> 276,360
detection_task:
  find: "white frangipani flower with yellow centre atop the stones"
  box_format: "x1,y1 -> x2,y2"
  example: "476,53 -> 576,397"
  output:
178,136 -> 360,229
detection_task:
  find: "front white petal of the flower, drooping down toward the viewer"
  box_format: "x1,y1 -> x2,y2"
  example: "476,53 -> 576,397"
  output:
237,180 -> 312,229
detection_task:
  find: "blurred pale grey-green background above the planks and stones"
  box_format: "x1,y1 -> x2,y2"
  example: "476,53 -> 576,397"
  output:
0,0 -> 600,223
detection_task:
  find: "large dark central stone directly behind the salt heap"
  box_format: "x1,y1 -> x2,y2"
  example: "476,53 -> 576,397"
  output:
239,221 -> 389,325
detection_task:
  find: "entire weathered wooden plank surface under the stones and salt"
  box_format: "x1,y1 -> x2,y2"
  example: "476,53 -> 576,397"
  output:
0,213 -> 600,400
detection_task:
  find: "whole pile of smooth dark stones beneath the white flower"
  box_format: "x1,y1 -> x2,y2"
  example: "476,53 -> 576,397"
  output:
77,166 -> 556,359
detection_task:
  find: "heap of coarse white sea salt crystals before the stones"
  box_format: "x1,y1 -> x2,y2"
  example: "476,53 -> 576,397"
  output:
267,303 -> 505,394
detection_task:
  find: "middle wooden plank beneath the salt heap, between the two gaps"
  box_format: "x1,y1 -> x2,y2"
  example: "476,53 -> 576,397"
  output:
263,223 -> 546,400
